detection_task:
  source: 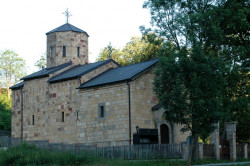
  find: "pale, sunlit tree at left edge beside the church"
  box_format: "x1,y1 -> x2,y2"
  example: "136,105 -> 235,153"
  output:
0,50 -> 25,99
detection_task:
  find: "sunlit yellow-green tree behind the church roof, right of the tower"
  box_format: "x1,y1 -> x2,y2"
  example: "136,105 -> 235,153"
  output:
97,32 -> 164,65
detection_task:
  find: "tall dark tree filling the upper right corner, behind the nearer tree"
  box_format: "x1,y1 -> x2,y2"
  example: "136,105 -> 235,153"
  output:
144,0 -> 250,161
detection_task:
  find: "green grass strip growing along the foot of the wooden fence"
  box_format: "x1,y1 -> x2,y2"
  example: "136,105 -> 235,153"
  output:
0,144 -> 250,166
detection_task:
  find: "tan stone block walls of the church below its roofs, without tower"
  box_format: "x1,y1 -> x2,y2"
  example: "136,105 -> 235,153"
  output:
12,65 -> 188,146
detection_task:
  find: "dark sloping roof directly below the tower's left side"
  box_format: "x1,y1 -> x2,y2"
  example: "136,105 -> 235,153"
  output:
21,62 -> 72,80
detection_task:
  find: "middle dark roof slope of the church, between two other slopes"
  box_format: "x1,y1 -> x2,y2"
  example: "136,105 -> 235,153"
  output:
48,59 -> 120,83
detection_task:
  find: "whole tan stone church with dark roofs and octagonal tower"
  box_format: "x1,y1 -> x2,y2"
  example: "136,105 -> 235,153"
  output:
10,23 -> 188,146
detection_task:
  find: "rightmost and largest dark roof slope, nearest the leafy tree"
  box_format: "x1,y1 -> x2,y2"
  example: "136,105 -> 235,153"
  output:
79,59 -> 159,88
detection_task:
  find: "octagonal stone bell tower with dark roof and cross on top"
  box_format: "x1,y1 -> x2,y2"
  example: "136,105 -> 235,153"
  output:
46,9 -> 89,68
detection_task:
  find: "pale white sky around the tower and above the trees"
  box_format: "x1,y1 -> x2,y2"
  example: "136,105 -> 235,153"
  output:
0,0 -> 150,74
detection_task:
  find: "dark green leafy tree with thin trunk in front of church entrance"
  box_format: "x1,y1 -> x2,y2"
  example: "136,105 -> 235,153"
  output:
154,47 -> 224,163
